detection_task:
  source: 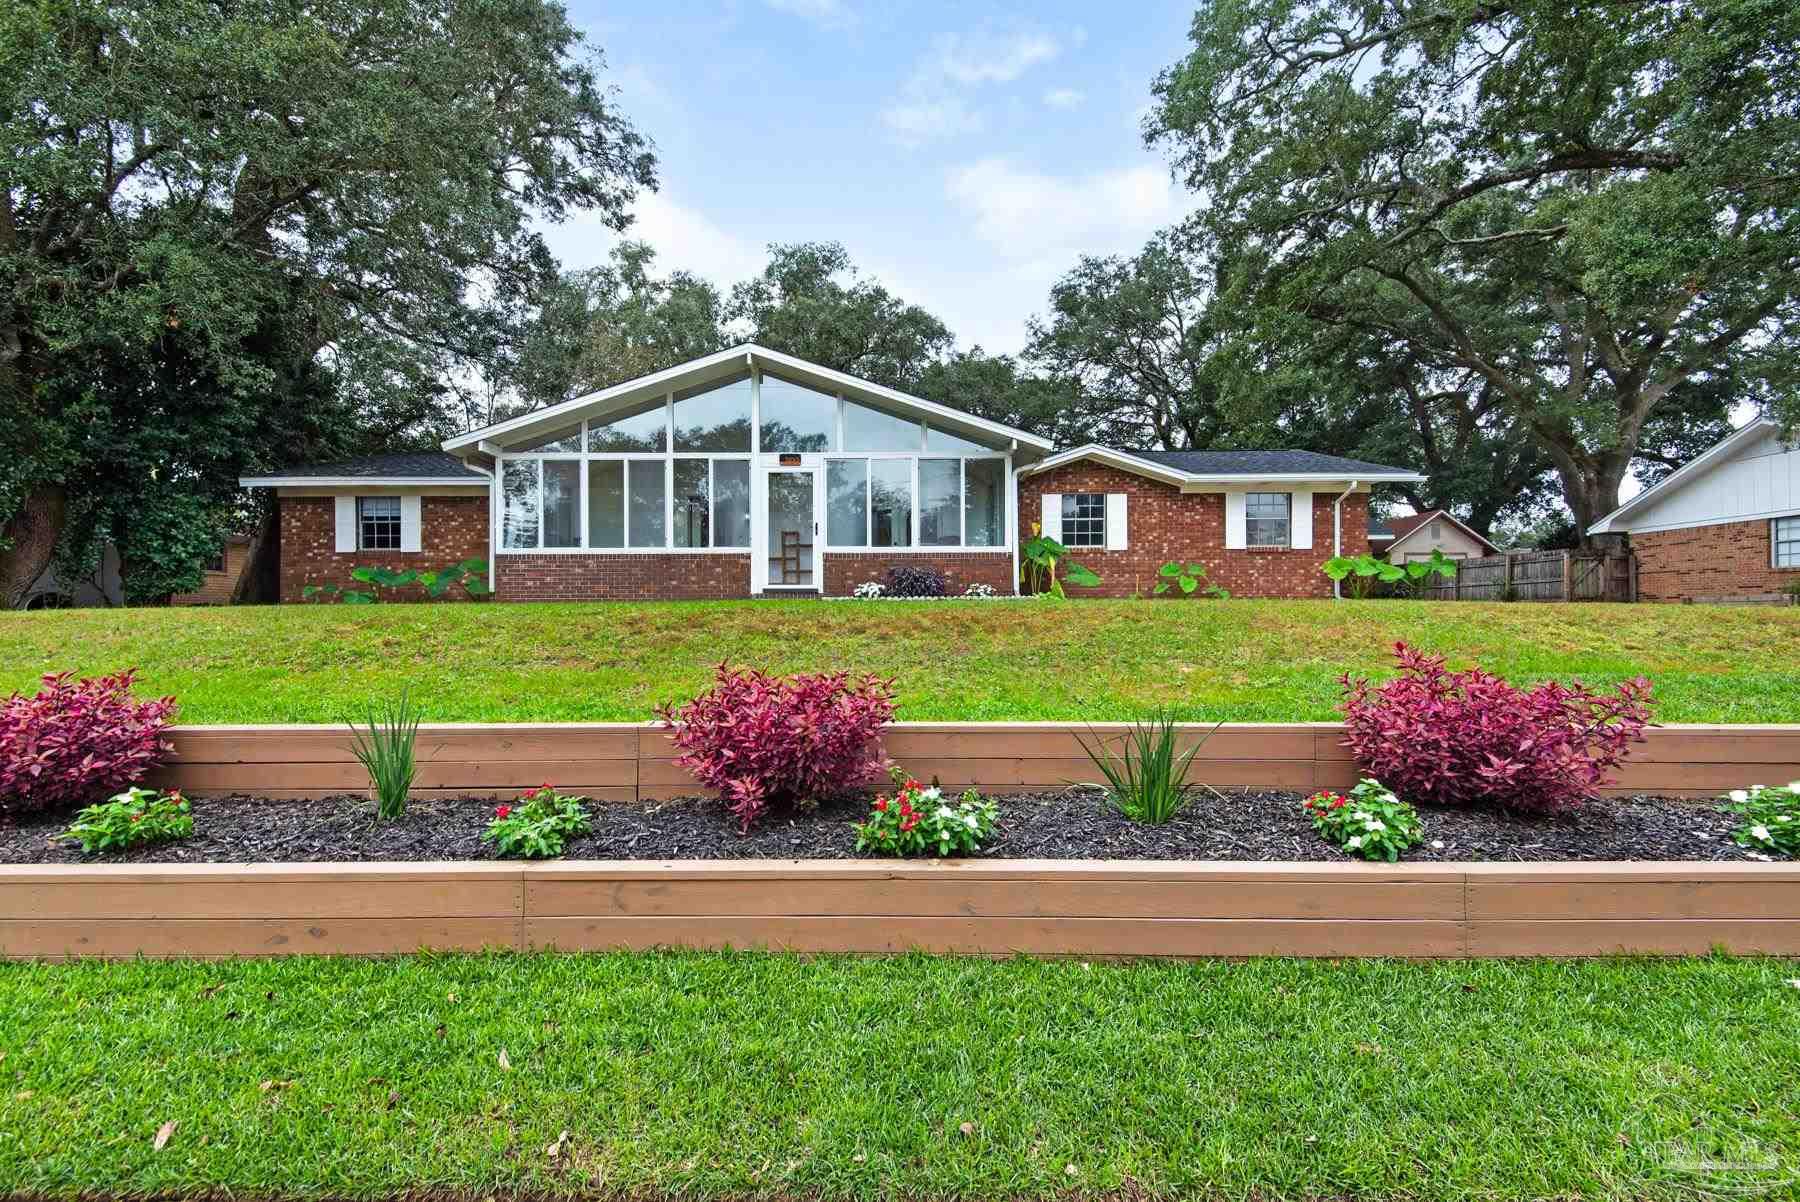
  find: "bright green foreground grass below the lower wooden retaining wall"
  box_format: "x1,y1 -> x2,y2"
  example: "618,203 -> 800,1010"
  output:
0,954 -> 1800,1200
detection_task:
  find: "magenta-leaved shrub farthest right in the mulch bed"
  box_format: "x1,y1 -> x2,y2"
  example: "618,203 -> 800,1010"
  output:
1339,642 -> 1651,813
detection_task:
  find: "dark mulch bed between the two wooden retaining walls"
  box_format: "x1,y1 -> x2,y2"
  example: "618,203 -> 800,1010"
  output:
0,790 -> 1750,864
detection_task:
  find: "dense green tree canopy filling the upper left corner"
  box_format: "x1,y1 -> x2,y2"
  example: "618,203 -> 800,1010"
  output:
0,0 -> 653,603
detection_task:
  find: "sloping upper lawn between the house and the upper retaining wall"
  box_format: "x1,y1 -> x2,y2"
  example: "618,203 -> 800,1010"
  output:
0,601 -> 1800,722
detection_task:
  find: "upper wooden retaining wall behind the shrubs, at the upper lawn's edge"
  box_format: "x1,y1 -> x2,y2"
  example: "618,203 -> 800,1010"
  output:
153,722 -> 1800,801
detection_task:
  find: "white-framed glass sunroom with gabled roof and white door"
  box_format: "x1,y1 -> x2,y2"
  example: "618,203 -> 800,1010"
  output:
443,345 -> 1049,594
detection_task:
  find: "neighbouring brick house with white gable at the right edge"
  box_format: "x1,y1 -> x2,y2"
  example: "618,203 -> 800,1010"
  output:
1589,421 -> 1800,603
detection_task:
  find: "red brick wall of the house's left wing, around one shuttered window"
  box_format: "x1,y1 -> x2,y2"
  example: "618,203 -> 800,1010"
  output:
281,497 -> 488,601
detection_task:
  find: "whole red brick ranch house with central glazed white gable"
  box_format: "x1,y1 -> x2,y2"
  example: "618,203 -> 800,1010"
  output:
243,345 -> 1420,601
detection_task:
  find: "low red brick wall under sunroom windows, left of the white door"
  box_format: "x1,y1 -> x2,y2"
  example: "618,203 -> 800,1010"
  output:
495,551 -> 751,601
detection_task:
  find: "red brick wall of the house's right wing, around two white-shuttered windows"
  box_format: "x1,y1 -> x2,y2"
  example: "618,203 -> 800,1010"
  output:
1019,462 -> 1368,597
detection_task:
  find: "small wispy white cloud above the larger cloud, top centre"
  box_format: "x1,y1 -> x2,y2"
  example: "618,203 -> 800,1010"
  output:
882,29 -> 1082,146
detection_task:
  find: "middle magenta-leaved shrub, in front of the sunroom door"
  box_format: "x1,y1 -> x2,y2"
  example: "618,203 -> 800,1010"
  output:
657,664 -> 895,830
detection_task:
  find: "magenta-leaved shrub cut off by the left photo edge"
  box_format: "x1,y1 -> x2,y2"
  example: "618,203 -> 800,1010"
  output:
0,669 -> 175,813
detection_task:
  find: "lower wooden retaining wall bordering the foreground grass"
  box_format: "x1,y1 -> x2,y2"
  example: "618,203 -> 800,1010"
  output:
0,860 -> 1800,959
